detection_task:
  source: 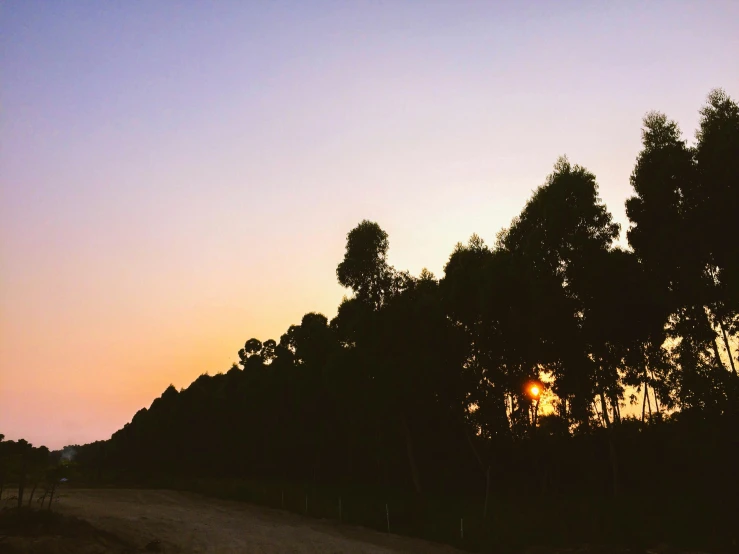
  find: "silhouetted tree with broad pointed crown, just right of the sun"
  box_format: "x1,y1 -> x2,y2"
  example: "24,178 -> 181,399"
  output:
498,158 -> 620,425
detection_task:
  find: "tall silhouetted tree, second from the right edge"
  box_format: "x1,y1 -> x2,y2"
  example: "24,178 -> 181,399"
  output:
626,112 -> 726,406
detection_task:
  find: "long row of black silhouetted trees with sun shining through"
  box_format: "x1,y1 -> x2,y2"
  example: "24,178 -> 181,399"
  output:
66,90 -> 739,544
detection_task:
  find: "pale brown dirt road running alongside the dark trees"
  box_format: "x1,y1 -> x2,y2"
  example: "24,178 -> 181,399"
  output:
55,489 -> 459,554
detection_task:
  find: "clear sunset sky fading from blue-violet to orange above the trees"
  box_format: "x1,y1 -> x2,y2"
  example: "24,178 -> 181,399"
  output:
0,0 -> 739,448
